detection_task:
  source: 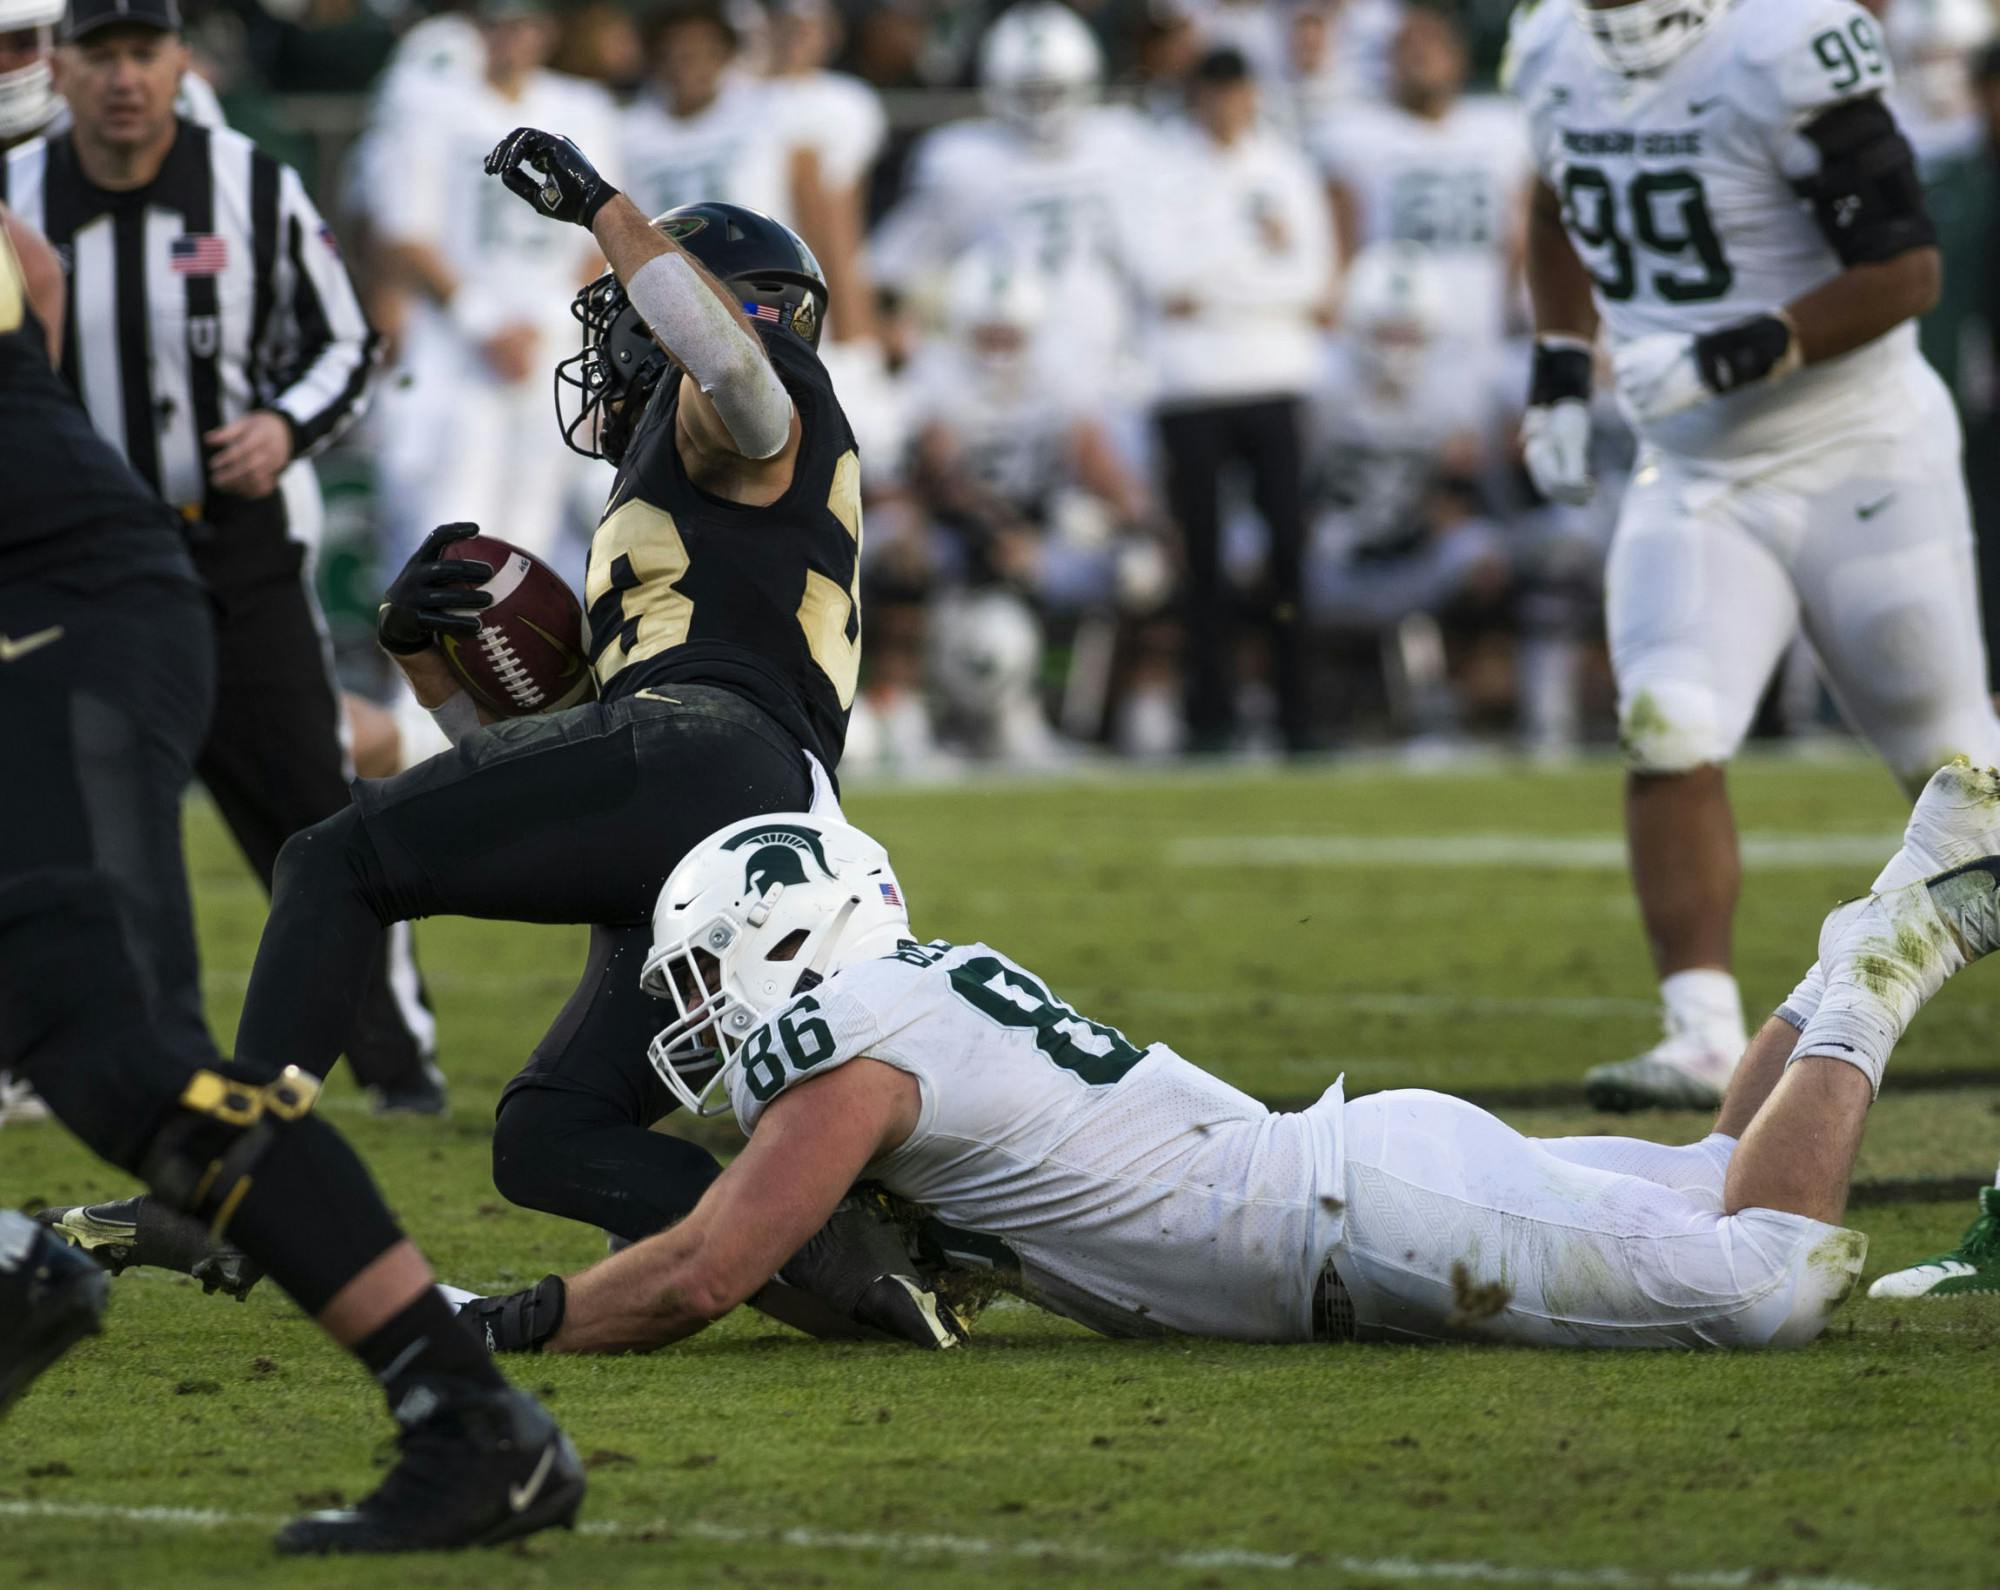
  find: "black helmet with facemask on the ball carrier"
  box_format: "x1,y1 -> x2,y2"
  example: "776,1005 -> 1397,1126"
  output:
556,204 -> 826,464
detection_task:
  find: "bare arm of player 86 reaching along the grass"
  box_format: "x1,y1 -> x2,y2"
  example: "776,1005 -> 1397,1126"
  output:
546,1060 -> 918,1352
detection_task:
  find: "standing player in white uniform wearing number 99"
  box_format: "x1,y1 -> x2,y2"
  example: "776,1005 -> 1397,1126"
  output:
1504,0 -> 2000,1110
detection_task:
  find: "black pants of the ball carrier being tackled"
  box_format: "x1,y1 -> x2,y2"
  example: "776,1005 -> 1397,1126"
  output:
236,684 -> 812,1240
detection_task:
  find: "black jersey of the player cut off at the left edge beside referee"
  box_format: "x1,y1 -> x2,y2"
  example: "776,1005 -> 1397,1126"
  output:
0,218 -> 194,580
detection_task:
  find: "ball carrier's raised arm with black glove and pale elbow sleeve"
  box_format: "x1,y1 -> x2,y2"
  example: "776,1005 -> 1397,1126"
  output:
486,128 -> 800,486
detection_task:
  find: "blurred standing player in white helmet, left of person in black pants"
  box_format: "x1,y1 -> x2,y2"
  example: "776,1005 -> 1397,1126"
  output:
872,0 -> 1152,410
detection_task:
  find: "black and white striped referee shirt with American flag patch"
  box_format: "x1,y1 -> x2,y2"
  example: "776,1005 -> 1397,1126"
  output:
0,122 -> 376,514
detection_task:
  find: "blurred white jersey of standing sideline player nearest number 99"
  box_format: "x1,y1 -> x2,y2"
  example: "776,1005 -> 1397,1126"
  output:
1314,98 -> 1534,342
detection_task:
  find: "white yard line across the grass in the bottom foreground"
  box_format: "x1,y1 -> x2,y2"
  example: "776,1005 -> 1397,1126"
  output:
0,1500 -> 1880,1590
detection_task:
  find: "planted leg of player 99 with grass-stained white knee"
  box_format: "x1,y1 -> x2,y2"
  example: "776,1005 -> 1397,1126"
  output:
1584,472 -> 1798,1110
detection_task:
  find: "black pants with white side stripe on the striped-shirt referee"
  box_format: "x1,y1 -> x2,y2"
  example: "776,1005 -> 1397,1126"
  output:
194,494 -> 432,1088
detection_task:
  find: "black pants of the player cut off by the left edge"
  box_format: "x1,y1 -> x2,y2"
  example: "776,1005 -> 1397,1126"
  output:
0,574 -> 400,1314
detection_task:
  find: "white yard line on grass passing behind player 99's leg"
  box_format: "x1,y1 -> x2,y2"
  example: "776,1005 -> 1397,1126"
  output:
1166,832 -> 1900,872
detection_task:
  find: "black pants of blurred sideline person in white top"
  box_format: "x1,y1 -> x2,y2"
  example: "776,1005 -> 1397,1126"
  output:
1156,398 -> 1312,750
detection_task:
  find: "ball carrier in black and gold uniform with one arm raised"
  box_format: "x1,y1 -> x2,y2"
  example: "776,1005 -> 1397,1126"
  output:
43,140 -> 952,1348
